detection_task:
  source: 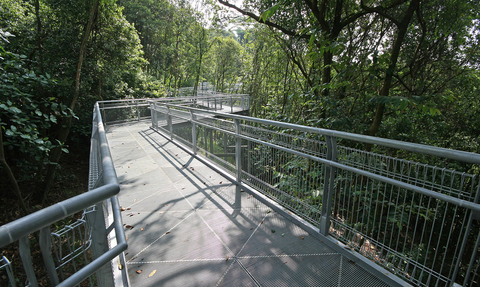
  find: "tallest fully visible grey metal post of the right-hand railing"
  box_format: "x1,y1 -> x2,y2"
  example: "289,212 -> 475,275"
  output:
320,136 -> 337,236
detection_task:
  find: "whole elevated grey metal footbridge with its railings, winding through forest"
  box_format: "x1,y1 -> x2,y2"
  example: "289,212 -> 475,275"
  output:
0,95 -> 480,286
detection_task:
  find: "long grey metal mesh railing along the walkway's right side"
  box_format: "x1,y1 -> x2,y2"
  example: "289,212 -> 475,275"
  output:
150,101 -> 480,286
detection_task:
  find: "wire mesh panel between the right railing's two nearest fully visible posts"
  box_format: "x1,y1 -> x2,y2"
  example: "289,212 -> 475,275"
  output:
242,141 -> 325,226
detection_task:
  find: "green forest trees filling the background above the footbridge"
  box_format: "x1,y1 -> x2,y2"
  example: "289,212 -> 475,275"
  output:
0,0 -> 480,212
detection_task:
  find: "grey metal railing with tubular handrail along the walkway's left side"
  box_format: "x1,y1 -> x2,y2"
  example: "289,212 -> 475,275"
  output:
0,103 -> 128,287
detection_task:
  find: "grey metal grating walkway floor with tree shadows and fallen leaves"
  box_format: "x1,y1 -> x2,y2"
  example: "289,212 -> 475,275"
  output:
107,122 -> 388,287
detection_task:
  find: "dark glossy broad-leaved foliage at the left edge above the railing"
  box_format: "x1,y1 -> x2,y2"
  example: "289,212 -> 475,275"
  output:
0,37 -> 73,180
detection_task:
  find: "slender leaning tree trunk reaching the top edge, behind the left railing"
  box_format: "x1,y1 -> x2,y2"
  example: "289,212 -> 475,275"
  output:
42,0 -> 100,205
